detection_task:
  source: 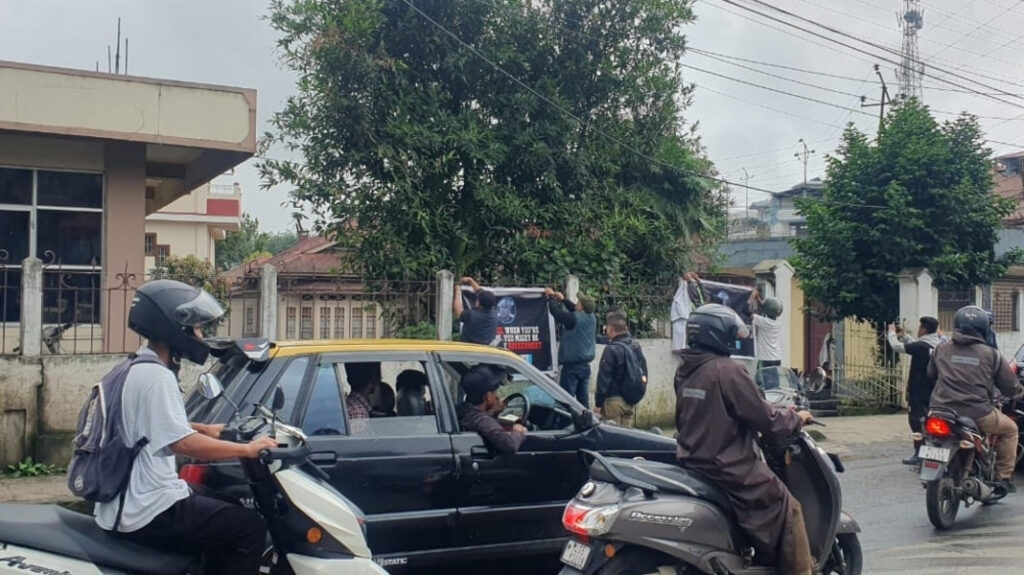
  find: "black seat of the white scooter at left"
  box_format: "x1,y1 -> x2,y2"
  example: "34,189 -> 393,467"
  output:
0,504 -> 199,575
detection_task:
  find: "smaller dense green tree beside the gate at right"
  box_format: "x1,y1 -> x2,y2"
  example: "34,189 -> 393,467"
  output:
793,100 -> 1017,323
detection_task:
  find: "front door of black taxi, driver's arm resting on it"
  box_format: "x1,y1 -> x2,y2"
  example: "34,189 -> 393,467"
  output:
438,352 -> 598,546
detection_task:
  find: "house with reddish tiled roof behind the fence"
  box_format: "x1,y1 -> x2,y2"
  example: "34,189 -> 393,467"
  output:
222,236 -> 383,341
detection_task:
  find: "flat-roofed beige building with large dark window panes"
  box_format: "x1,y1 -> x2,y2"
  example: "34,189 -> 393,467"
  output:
0,61 -> 256,355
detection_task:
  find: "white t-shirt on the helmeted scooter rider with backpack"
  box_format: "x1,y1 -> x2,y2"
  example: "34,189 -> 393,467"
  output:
95,348 -> 196,533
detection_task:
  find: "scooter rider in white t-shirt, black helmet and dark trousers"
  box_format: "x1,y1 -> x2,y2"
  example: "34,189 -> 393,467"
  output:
95,279 -> 278,574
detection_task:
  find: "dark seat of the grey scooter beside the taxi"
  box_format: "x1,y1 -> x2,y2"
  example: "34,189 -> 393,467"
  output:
590,457 -> 734,516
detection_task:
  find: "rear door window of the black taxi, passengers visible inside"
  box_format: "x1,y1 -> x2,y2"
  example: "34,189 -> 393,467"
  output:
310,353 -> 439,437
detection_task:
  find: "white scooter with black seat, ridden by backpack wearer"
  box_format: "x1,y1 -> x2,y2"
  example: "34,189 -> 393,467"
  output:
0,373 -> 387,575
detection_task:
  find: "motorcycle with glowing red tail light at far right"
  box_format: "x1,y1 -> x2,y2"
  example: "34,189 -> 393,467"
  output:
913,401 -> 1007,529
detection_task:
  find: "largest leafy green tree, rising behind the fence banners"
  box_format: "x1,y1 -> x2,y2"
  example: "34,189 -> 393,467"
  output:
261,0 -> 725,289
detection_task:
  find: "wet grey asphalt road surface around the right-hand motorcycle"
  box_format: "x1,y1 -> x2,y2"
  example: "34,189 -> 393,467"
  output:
841,441 -> 1024,575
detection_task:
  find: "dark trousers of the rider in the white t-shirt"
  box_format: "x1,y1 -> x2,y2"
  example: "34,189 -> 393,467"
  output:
119,487 -> 266,575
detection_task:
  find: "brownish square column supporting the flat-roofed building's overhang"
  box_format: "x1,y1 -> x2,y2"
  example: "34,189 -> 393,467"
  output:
100,141 -> 145,353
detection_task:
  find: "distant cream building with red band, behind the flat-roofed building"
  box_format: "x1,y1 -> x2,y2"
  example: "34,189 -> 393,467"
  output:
144,178 -> 242,274
